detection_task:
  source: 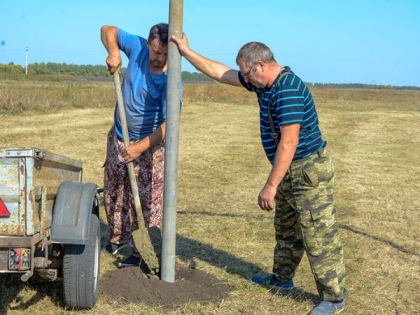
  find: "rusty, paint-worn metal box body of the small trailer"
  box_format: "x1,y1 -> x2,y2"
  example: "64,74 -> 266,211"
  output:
0,148 -> 82,281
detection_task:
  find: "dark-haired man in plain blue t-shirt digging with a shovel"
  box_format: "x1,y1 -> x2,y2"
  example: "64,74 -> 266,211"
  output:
101,23 -> 173,266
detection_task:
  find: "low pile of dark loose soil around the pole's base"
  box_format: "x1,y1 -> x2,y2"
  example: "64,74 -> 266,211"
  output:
100,266 -> 231,309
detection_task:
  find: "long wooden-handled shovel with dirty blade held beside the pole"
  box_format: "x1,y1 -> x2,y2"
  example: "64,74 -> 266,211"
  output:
114,71 -> 159,275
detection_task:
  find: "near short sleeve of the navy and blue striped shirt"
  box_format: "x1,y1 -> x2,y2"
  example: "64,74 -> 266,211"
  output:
273,80 -> 304,126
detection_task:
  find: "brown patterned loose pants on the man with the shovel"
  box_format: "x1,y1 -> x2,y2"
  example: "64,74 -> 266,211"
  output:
104,127 -> 165,244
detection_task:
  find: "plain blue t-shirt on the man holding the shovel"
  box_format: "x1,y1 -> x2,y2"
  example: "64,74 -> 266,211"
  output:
114,29 -> 182,140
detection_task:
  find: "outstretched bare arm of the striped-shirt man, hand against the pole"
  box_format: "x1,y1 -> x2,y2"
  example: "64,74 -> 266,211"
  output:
172,34 -> 242,86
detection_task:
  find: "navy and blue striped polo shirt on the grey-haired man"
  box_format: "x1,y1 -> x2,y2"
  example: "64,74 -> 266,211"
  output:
238,67 -> 327,164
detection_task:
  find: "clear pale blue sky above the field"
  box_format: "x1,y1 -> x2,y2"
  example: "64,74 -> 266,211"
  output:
0,0 -> 420,86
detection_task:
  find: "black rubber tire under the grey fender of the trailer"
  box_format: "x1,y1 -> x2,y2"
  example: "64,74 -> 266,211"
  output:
63,213 -> 101,309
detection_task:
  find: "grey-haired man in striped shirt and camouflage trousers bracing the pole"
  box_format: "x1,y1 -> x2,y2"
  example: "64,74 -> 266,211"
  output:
172,34 -> 345,314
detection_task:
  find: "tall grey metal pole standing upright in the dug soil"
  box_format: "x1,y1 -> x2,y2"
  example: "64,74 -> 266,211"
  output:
161,0 -> 184,283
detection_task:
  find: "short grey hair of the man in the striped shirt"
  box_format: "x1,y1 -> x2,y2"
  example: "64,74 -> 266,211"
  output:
236,42 -> 276,68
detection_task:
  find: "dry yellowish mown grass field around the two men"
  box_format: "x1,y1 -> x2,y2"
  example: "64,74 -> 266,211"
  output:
0,81 -> 420,314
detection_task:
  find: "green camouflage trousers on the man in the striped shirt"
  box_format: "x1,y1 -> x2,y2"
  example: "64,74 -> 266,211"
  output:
273,149 -> 345,301
